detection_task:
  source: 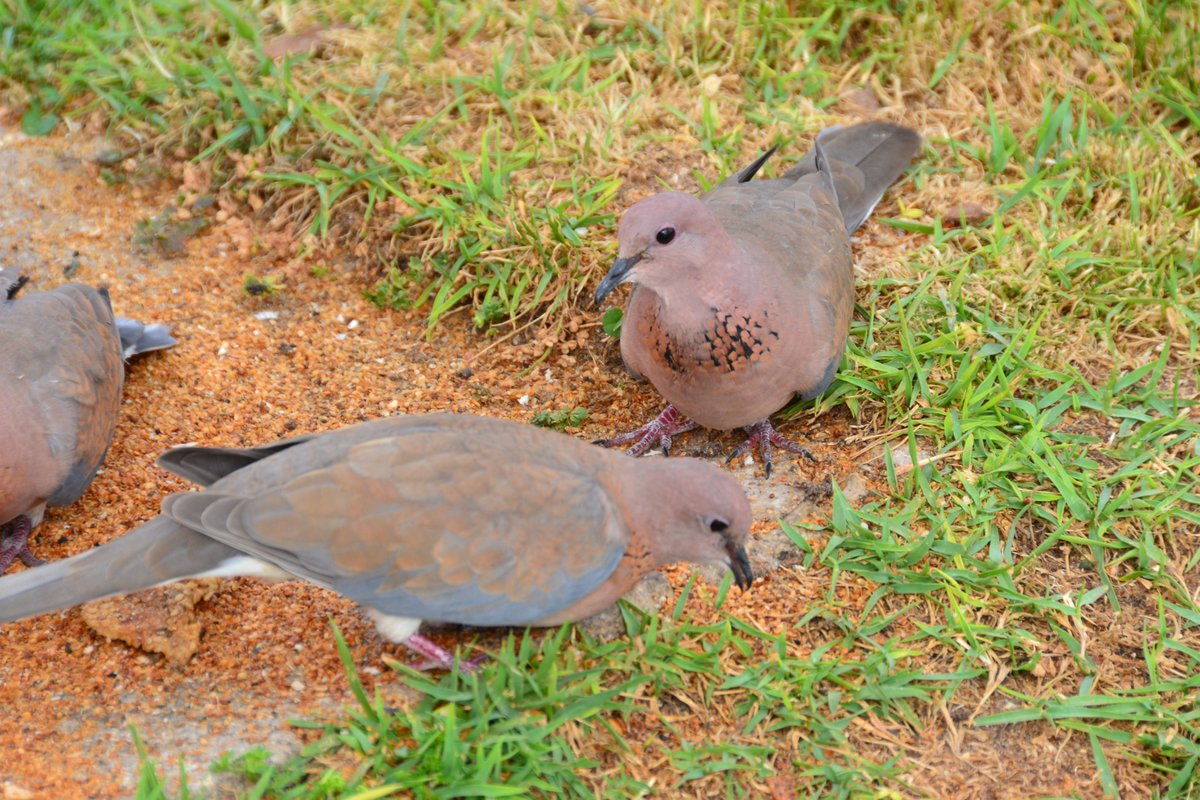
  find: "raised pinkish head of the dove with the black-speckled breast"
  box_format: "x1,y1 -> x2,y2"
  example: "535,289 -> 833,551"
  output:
595,192 -> 730,305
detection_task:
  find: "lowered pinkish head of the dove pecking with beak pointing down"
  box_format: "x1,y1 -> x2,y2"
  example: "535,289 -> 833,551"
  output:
625,458 -> 754,589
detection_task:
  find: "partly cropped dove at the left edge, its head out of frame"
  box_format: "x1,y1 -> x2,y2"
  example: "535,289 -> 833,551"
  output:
0,269 -> 175,572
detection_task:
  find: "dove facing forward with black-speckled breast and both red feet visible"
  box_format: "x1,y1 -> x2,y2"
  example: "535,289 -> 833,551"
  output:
595,122 -> 920,477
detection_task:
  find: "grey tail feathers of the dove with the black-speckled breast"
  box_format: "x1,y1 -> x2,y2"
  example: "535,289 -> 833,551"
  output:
786,122 -> 922,233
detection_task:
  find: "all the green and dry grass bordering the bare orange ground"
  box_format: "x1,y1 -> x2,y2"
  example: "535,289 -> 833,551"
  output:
9,0 -> 1200,798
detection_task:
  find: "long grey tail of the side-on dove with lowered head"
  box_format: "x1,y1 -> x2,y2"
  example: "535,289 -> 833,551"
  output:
0,517 -> 240,622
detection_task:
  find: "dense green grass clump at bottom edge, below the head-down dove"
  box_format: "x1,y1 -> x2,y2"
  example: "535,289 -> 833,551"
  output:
227,631 -> 642,796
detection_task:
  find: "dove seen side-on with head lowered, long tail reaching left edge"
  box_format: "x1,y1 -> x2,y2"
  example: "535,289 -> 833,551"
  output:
0,414 -> 754,668
